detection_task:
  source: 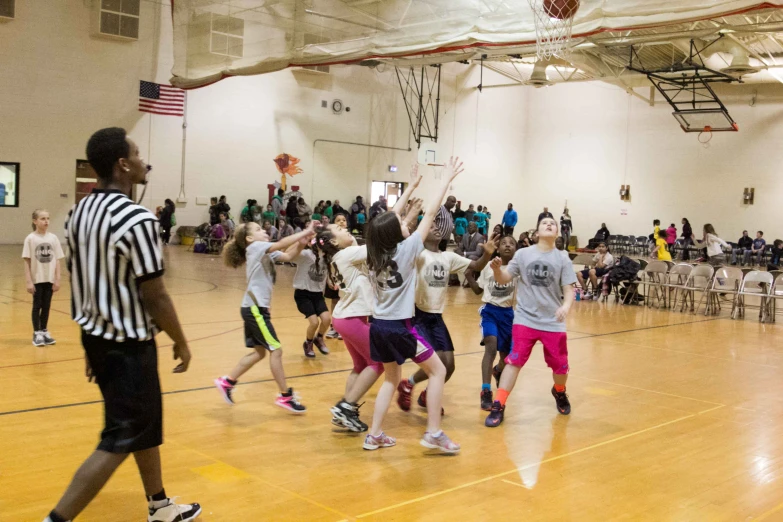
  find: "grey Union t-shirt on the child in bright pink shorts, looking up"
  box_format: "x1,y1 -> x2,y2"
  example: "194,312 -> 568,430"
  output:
507,245 -> 576,332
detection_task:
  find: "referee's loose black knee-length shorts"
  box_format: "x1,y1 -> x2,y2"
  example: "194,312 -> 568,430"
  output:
82,332 -> 163,453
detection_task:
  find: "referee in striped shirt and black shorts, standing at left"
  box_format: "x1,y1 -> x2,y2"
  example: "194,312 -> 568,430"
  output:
45,128 -> 201,522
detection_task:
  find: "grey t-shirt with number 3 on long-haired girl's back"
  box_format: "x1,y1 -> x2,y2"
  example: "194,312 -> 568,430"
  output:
371,231 -> 424,321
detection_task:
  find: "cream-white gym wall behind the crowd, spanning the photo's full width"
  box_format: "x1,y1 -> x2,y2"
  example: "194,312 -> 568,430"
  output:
0,0 -> 783,243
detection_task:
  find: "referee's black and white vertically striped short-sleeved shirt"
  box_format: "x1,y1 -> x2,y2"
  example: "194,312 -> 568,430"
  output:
65,189 -> 163,342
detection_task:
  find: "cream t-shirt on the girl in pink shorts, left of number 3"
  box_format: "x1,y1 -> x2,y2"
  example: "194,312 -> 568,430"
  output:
332,246 -> 373,319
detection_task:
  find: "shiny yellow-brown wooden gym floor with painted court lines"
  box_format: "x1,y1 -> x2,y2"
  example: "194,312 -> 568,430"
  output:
0,246 -> 783,522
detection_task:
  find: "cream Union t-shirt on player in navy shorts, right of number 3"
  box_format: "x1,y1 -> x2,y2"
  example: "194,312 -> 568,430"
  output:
416,249 -> 471,314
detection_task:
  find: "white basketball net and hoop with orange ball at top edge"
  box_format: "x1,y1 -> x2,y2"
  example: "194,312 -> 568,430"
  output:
528,0 -> 579,60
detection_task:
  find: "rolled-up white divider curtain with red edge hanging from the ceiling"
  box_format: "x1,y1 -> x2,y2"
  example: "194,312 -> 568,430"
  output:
171,0 -> 783,88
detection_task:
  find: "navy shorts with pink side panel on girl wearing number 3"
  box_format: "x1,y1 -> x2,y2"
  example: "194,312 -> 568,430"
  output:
370,318 -> 434,364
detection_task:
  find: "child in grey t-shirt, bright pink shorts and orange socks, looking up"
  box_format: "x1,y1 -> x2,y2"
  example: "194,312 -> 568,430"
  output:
484,213 -> 576,428
